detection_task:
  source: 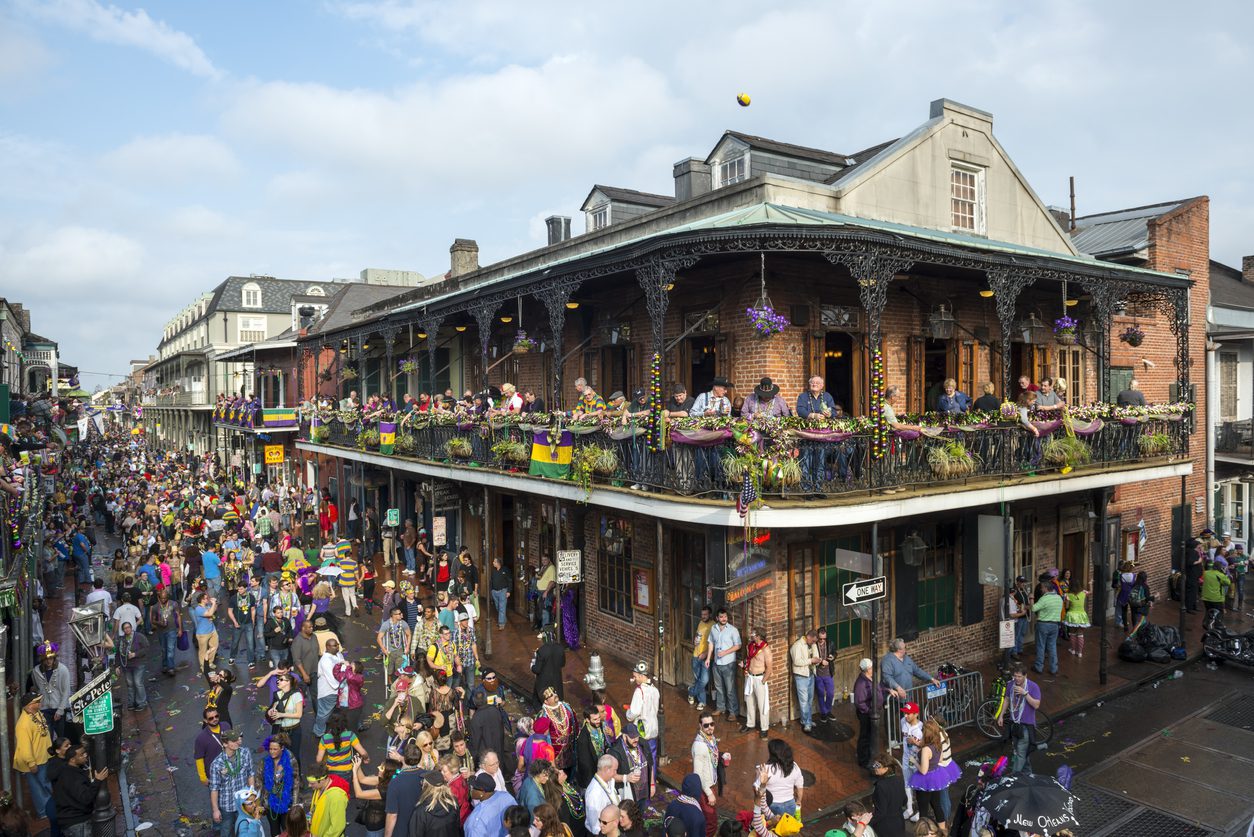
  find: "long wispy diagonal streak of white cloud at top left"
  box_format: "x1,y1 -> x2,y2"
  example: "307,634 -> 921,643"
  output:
20,0 -> 222,79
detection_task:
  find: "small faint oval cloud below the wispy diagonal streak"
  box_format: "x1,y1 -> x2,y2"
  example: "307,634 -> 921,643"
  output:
103,134 -> 240,184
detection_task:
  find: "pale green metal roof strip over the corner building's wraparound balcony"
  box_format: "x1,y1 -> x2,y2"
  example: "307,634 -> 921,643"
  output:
394,202 -> 1181,312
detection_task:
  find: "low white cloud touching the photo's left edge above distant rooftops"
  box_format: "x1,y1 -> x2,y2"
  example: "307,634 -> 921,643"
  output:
0,226 -> 144,289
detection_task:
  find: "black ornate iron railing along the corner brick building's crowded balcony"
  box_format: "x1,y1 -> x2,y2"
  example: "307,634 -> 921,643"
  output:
301,418 -> 1189,499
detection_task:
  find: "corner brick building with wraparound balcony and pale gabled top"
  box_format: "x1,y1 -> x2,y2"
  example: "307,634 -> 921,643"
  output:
288,99 -> 1208,720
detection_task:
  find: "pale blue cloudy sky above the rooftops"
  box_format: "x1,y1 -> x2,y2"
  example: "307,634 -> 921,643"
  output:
0,0 -> 1254,389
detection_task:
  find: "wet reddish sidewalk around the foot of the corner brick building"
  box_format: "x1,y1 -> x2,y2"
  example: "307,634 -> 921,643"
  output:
485,602 -> 1254,822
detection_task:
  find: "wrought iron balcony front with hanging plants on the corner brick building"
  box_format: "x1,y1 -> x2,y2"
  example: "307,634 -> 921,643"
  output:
301,414 -> 1191,499
